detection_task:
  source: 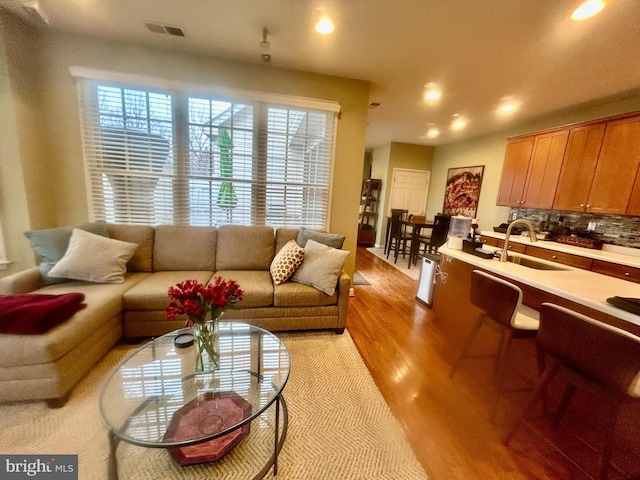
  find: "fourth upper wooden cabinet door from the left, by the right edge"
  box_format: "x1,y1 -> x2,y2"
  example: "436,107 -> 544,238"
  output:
586,116 -> 640,215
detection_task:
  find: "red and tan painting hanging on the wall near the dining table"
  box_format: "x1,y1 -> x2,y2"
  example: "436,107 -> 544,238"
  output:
442,165 -> 484,218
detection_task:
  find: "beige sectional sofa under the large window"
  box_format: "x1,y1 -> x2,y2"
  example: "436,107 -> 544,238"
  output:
0,224 -> 351,406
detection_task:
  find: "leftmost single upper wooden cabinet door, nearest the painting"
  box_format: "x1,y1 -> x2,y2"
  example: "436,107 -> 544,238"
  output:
496,136 -> 533,207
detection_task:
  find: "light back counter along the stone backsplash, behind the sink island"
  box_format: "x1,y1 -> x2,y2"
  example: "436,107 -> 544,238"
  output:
480,231 -> 640,268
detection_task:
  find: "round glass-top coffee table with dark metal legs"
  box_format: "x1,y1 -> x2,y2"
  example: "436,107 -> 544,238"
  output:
100,322 -> 290,479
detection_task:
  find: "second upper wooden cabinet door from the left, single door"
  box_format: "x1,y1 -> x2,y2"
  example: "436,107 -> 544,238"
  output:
521,129 -> 569,208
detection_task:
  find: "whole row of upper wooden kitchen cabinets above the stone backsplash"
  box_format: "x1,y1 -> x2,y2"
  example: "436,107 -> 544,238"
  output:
496,112 -> 640,216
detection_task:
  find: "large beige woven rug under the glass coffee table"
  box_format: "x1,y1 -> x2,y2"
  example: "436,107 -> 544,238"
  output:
0,331 -> 427,480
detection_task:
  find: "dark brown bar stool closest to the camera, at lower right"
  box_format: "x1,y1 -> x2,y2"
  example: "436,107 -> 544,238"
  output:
503,303 -> 640,480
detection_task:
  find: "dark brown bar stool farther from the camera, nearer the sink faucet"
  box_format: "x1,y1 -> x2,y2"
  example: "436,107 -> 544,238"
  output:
449,270 -> 543,419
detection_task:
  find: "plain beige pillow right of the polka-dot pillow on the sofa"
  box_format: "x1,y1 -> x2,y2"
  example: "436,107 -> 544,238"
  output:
291,239 -> 349,295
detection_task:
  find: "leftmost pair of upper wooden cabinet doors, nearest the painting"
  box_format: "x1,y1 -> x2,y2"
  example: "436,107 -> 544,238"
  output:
496,129 -> 569,208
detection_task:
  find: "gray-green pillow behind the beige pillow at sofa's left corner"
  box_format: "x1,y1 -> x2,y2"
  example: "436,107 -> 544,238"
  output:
24,221 -> 109,285
